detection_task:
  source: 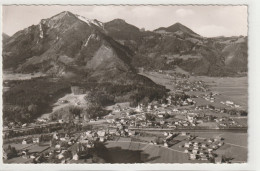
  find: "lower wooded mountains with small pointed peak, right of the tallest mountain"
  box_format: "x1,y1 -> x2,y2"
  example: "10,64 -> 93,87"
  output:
102,19 -> 247,76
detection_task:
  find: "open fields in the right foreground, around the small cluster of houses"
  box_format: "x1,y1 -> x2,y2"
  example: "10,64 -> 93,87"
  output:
103,132 -> 247,163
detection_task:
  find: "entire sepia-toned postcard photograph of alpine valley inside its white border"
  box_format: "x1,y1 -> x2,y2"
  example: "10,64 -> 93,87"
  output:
1,5 -> 256,168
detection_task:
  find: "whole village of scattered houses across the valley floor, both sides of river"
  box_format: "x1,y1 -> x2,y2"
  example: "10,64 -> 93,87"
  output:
3,70 -> 247,163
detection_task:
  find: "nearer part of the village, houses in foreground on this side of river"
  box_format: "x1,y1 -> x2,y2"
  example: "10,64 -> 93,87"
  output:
3,119 -> 245,163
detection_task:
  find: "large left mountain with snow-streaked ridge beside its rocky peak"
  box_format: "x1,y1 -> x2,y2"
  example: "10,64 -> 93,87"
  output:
3,11 -> 167,88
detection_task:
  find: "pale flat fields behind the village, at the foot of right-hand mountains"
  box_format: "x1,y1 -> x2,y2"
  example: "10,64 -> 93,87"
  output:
141,71 -> 248,109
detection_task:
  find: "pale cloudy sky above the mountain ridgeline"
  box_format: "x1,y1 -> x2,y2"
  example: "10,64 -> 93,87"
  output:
2,5 -> 248,37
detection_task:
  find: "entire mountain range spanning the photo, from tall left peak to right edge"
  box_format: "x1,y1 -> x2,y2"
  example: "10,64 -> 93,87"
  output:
3,12 -> 247,79
